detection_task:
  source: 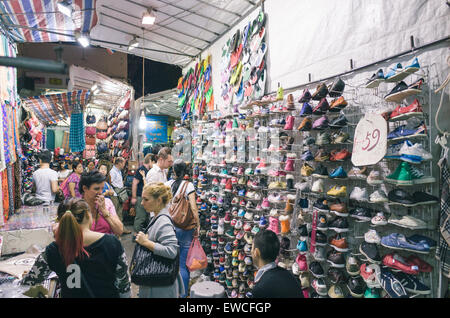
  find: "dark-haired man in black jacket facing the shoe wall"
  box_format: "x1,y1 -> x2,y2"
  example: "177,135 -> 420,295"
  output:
252,230 -> 303,298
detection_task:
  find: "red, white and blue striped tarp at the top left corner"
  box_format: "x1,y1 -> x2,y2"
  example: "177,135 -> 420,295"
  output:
0,0 -> 97,42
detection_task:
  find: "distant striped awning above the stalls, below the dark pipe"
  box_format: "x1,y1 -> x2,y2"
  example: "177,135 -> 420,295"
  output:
24,90 -> 90,125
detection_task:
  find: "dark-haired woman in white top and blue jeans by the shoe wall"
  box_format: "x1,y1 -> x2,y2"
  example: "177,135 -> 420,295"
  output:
165,159 -> 200,298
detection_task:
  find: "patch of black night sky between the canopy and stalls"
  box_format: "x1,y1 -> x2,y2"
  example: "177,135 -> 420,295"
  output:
128,54 -> 182,99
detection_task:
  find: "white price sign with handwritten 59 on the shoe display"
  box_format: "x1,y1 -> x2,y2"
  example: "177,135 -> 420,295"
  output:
352,114 -> 387,166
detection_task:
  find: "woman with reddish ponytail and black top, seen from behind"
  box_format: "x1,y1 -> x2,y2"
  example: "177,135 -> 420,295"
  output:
22,199 -> 130,298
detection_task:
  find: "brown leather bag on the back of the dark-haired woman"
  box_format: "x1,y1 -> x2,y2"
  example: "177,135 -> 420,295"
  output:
169,181 -> 196,231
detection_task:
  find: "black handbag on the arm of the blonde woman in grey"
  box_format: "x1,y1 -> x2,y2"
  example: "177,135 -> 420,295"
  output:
130,214 -> 180,287
